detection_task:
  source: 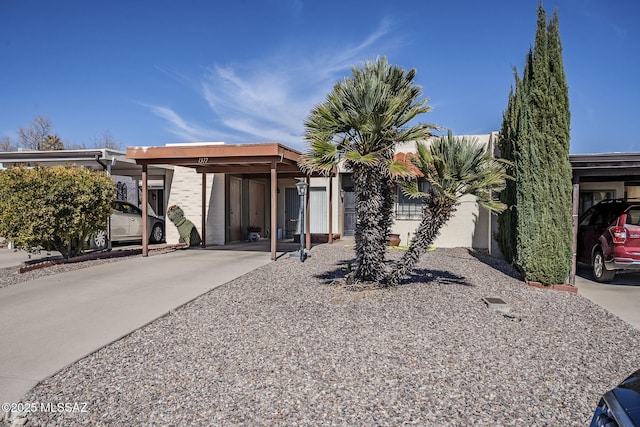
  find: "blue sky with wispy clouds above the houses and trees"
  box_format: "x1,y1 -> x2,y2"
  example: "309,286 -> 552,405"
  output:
0,0 -> 640,153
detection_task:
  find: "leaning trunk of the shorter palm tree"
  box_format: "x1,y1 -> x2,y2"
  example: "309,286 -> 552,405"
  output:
386,193 -> 456,286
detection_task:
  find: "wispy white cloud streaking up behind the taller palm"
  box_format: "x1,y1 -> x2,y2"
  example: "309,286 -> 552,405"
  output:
148,21 -> 396,149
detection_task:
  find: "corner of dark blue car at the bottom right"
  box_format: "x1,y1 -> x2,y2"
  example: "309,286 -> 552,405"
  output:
591,369 -> 640,427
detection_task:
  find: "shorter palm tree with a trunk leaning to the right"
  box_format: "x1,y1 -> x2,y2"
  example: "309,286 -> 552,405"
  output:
387,131 -> 508,285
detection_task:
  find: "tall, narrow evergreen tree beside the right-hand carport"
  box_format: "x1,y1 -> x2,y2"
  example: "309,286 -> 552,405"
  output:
498,4 -> 572,284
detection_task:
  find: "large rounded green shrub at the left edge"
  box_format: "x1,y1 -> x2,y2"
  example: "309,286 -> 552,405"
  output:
0,166 -> 115,258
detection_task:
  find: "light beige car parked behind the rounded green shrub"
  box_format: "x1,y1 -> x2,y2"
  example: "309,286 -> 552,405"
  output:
90,200 -> 164,250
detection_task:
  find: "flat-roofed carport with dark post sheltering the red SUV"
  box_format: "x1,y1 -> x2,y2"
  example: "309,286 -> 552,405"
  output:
569,153 -> 640,285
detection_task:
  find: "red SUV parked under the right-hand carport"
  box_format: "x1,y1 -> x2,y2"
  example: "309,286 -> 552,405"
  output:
578,199 -> 640,282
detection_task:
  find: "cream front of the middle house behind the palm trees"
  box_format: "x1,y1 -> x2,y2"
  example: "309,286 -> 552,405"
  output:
136,133 -> 497,252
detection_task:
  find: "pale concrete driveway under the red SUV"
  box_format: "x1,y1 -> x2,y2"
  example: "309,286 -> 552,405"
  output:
576,268 -> 640,330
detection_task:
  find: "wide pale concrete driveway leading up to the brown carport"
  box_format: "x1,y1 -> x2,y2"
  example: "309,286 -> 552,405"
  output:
0,249 -> 270,403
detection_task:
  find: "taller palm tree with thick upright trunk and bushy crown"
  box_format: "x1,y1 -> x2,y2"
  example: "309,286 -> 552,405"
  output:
300,57 -> 434,282
